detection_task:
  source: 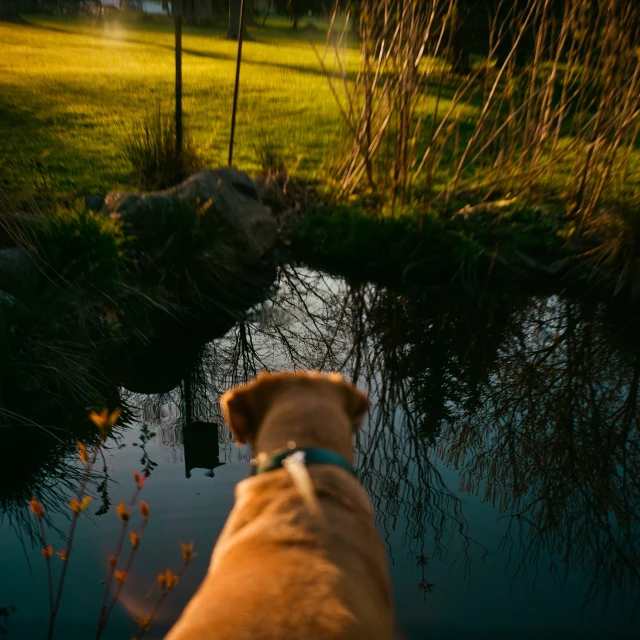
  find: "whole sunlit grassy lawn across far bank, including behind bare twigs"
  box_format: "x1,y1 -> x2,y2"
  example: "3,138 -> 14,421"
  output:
0,10 -> 640,300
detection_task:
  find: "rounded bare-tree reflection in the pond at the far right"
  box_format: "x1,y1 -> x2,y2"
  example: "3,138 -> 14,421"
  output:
440,298 -> 640,608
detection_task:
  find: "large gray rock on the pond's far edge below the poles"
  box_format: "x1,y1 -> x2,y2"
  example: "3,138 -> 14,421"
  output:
102,167 -> 278,263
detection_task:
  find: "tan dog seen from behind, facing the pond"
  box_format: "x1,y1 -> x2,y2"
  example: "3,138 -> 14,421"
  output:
167,372 -> 394,640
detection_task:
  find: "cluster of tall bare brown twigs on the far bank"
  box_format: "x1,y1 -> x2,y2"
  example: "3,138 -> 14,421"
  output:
318,0 -> 640,220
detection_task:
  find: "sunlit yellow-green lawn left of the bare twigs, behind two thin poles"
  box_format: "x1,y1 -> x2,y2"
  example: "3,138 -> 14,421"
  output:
0,17 -> 358,201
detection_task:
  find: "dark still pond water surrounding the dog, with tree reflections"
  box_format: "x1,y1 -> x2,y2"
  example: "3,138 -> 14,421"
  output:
0,267 -> 640,640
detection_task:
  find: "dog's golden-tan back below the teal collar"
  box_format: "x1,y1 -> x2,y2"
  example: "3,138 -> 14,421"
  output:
168,370 -> 393,640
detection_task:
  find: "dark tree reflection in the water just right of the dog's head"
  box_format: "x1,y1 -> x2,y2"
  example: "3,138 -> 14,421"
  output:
354,287 -> 524,584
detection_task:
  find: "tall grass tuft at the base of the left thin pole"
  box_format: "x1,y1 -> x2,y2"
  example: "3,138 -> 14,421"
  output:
125,105 -> 204,191
